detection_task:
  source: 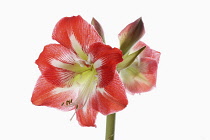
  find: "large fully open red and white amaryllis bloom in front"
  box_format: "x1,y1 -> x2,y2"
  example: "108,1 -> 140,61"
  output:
31,16 -> 128,126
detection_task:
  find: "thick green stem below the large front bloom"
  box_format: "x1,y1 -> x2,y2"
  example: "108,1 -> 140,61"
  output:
105,113 -> 116,140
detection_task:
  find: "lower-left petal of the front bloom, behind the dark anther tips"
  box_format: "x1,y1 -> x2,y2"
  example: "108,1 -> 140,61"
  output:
31,76 -> 76,111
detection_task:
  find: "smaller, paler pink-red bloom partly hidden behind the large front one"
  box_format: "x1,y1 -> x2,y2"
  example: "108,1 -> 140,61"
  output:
120,41 -> 160,94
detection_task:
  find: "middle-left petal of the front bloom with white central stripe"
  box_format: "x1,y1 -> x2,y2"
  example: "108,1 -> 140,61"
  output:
36,44 -> 83,86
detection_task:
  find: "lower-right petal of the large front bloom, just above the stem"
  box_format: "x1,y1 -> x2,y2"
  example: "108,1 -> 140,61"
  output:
91,72 -> 128,115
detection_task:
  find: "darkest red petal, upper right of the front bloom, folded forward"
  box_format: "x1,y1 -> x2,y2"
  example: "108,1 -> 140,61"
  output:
89,43 -> 123,87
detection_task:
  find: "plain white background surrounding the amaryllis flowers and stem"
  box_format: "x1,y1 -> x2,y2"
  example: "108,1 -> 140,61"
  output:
0,0 -> 210,140
